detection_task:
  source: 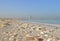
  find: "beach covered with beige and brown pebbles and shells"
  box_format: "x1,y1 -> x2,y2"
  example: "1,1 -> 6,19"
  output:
0,19 -> 60,41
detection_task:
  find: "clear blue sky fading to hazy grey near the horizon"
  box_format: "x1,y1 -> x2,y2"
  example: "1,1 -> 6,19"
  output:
0,0 -> 60,18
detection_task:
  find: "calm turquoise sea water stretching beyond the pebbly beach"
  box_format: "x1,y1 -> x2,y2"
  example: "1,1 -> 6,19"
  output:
21,20 -> 60,24
